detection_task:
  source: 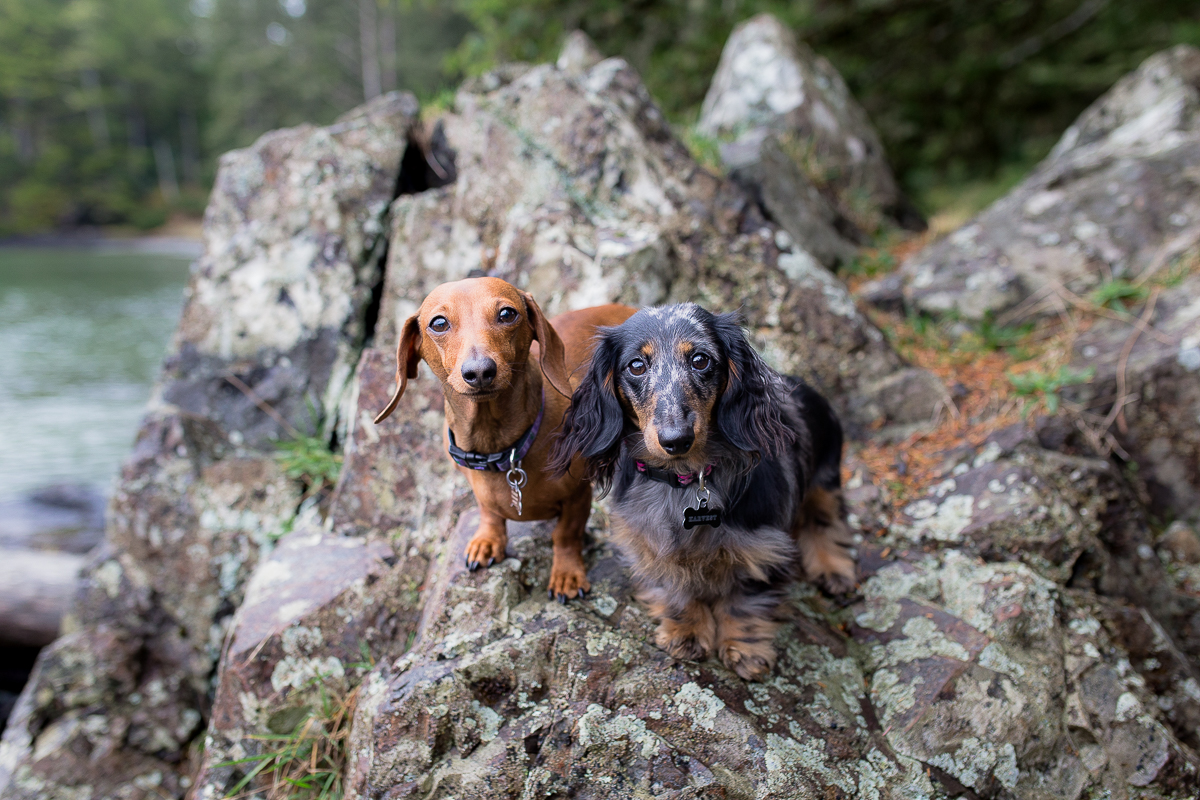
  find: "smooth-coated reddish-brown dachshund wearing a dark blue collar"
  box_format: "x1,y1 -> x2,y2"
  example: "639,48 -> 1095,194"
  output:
376,277 -> 635,602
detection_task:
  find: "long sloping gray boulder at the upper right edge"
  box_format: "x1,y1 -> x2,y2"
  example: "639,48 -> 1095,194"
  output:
902,44 -> 1200,320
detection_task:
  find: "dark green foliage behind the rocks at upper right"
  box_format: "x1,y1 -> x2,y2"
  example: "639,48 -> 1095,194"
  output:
456,0 -> 1200,189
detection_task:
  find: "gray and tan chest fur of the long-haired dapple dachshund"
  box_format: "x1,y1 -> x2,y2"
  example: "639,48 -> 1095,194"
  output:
613,459 -> 799,597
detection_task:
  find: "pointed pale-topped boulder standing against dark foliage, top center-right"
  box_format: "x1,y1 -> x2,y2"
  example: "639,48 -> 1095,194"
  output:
697,14 -> 925,236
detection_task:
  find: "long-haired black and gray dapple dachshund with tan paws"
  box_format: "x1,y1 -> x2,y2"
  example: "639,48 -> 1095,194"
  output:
551,303 -> 854,680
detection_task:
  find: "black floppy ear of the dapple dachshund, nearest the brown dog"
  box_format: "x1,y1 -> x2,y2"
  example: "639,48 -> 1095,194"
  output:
547,329 -> 625,495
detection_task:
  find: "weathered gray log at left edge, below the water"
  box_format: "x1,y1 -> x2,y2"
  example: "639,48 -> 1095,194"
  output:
0,548 -> 86,646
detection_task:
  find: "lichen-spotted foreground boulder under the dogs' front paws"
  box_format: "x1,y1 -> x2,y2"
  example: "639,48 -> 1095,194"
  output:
347,518 -> 935,799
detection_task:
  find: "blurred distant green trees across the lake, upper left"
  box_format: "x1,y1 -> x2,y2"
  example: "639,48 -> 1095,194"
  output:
0,0 -> 468,235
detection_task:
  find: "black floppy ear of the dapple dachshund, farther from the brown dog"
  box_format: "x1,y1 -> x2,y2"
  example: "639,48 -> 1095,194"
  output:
714,313 -> 794,457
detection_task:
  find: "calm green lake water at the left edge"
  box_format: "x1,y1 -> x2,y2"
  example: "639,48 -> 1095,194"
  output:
0,247 -> 191,498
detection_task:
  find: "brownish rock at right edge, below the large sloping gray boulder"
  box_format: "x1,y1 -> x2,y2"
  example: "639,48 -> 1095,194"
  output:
1066,272 -> 1200,521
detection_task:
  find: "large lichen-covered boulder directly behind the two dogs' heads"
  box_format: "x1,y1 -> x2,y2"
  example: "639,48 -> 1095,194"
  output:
376,51 -> 944,431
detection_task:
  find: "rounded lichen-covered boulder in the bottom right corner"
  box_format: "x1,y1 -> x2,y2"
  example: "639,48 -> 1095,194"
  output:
850,549 -> 1200,800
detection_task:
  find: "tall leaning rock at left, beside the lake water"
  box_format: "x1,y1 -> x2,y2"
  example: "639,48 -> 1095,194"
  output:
0,94 -> 418,799
